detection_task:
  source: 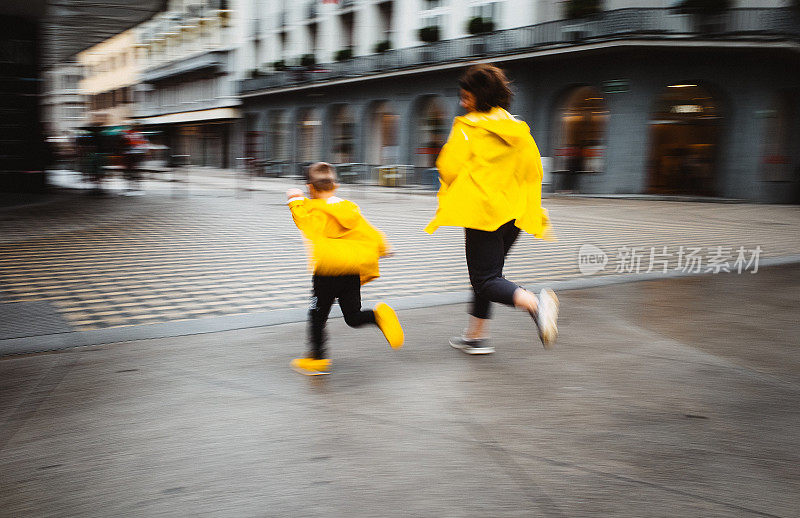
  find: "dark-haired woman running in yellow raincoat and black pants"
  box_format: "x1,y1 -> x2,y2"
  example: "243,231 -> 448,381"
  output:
425,65 -> 558,354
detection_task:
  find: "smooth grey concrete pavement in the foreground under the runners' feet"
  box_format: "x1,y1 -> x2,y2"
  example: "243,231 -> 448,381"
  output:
0,266 -> 800,517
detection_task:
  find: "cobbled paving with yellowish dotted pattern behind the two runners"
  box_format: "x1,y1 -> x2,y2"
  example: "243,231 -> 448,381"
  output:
0,175 -> 800,338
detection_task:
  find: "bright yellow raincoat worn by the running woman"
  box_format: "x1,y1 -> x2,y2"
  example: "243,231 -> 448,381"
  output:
425,107 -> 552,239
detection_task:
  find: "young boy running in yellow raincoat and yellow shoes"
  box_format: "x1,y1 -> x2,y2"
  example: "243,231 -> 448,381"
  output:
286,162 -> 404,376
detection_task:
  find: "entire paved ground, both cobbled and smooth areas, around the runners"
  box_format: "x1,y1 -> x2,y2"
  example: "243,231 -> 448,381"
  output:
0,172 -> 800,517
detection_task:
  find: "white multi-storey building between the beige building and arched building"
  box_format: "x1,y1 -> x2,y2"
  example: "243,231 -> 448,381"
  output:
135,0 -> 243,167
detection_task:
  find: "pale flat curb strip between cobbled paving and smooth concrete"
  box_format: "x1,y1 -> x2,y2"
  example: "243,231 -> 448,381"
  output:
0,255 -> 800,359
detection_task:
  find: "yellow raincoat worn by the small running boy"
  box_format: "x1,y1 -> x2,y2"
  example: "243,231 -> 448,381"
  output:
289,196 -> 387,284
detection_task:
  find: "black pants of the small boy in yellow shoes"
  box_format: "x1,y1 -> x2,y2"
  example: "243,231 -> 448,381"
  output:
308,275 -> 375,359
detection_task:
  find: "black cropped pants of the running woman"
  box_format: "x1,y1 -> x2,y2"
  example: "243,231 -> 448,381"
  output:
464,220 -> 519,318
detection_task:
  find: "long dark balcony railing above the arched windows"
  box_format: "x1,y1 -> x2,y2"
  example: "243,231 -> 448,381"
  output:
240,8 -> 800,93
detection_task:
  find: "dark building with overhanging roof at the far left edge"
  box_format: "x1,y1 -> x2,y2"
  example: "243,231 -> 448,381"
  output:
0,0 -> 165,192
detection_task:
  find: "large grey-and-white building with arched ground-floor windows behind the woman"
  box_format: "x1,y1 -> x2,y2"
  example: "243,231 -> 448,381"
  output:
240,0 -> 800,202
